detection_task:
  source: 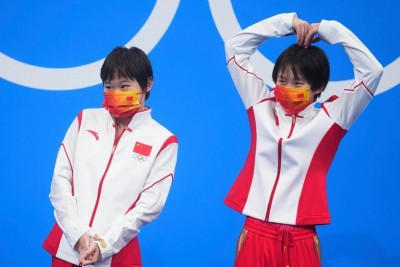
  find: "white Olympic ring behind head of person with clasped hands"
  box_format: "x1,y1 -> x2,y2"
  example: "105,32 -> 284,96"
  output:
0,0 -> 179,90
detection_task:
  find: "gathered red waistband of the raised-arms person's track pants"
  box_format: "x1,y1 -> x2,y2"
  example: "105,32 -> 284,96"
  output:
244,217 -> 317,240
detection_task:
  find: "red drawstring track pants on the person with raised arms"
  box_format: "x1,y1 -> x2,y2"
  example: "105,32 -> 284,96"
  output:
235,217 -> 321,267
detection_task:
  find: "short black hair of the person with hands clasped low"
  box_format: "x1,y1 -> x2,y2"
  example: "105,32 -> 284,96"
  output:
100,46 -> 154,99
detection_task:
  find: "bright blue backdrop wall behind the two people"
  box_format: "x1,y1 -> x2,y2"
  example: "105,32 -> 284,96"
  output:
0,0 -> 400,267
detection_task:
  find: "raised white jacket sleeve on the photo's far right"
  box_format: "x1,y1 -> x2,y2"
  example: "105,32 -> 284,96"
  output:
318,20 -> 383,129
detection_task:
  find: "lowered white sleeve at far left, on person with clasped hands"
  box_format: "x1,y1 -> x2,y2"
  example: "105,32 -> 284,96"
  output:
49,114 -> 90,248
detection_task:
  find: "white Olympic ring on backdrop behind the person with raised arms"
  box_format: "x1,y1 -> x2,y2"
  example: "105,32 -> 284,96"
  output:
208,0 -> 400,100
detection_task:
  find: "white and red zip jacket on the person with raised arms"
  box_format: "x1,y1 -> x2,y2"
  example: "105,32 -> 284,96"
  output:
225,13 -> 383,225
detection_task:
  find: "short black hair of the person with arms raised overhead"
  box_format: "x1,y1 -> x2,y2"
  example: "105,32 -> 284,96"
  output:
272,44 -> 330,98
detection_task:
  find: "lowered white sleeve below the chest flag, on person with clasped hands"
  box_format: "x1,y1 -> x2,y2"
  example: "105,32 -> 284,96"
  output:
97,143 -> 178,260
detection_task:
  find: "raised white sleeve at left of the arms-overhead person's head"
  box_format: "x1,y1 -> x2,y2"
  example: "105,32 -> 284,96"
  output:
225,13 -> 295,109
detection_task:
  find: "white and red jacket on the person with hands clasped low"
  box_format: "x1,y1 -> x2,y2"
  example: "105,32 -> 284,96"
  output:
43,108 -> 178,266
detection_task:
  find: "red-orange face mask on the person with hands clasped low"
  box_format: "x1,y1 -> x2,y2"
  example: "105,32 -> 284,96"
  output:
103,91 -> 142,119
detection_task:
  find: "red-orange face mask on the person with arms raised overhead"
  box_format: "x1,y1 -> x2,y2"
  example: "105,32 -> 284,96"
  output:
275,85 -> 312,114
